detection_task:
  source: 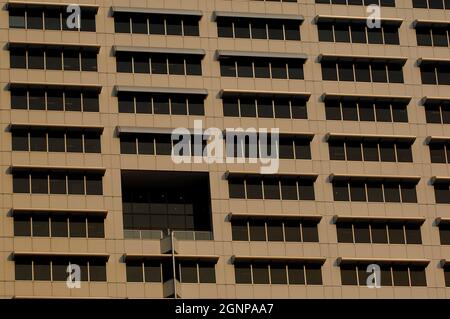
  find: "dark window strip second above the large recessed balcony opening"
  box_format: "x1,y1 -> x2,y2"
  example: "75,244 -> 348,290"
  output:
117,92 -> 205,115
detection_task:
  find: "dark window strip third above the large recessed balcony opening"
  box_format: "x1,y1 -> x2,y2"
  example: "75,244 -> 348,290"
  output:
116,52 -> 203,75
